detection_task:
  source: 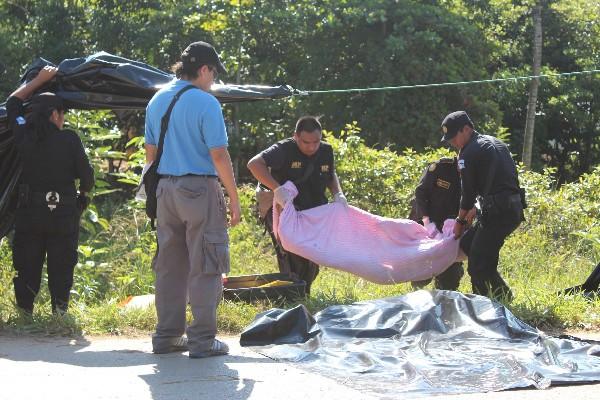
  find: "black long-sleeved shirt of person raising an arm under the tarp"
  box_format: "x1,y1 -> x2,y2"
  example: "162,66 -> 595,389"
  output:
6,96 -> 94,196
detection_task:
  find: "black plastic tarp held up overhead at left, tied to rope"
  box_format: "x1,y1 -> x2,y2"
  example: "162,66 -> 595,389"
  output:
0,52 -> 297,238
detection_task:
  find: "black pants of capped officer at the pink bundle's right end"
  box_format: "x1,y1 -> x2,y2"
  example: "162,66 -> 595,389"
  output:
461,198 -> 523,301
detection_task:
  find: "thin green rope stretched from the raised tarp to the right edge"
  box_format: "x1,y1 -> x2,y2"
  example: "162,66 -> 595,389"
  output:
294,69 -> 600,95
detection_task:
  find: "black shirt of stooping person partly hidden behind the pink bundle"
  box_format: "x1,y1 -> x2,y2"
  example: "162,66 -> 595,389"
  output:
415,158 -> 460,225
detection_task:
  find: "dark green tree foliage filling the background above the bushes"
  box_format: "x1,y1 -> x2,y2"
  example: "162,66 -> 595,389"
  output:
0,0 -> 600,181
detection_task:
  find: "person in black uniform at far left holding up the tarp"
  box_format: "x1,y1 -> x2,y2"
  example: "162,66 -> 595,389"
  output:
6,66 -> 94,314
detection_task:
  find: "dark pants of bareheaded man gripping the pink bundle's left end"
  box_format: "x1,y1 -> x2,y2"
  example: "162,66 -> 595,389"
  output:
263,210 -> 319,295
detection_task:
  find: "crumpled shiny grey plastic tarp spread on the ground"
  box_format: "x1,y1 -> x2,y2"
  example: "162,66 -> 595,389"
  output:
240,290 -> 600,396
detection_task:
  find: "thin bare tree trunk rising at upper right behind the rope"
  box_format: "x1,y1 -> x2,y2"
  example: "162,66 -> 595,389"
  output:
522,2 -> 542,169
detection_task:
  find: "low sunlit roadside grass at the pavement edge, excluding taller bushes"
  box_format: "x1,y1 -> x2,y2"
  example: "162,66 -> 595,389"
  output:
0,228 -> 600,336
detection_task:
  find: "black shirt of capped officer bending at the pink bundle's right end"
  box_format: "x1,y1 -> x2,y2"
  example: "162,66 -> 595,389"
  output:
458,132 -> 519,210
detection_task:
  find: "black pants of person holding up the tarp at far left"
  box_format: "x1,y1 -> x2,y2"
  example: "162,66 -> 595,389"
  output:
13,206 -> 79,313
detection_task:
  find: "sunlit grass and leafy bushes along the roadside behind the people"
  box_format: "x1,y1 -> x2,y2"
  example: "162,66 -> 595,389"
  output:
0,141 -> 600,336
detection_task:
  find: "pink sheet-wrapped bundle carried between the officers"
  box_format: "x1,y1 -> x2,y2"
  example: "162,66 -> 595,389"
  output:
273,182 -> 459,284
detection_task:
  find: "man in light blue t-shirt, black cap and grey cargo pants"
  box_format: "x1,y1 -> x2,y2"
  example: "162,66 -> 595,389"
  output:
145,42 -> 241,358
